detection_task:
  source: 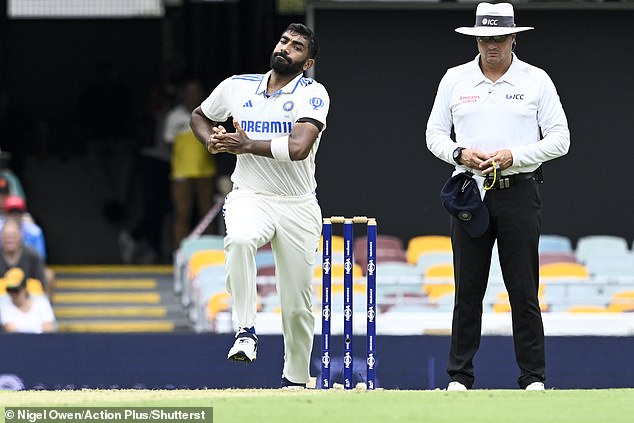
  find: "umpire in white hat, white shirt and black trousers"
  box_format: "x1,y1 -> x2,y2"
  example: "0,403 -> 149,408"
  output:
426,3 -> 570,390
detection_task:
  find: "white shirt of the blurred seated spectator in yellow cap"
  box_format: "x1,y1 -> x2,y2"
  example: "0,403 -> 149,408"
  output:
0,296 -> 55,333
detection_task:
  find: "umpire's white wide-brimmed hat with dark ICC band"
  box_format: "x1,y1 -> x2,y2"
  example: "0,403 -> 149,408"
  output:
456,3 -> 534,37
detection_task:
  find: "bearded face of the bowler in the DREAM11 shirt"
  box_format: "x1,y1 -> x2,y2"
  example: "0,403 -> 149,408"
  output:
271,31 -> 314,76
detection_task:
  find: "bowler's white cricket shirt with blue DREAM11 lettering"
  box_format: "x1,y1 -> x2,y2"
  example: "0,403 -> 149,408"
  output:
201,71 -> 330,196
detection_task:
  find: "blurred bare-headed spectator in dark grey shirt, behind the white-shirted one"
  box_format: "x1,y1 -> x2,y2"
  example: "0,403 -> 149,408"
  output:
0,217 -> 53,298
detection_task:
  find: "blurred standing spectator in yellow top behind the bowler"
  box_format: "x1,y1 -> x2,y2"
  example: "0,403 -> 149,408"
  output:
165,79 -> 216,249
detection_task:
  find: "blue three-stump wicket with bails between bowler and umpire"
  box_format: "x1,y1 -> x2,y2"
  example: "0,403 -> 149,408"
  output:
321,216 -> 377,389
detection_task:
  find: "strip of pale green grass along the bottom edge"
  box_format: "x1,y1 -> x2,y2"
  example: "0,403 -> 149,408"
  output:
0,389 -> 634,423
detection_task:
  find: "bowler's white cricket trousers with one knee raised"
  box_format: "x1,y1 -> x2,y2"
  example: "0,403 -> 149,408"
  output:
224,189 -> 321,383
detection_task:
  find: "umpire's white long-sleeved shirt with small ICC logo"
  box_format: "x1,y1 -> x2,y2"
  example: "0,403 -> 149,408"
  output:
426,54 -> 570,179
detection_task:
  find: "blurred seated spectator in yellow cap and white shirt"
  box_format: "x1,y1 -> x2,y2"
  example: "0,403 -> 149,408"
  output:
0,267 -> 55,333
